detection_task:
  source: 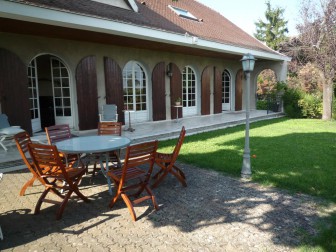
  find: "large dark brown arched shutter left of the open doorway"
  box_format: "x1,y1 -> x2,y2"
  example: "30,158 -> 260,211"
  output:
0,48 -> 32,134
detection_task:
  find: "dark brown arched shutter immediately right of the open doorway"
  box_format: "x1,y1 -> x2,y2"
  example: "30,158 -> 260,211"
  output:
76,56 -> 98,130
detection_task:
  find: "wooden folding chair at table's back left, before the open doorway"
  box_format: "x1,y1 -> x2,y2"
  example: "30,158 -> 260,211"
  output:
45,124 -> 81,166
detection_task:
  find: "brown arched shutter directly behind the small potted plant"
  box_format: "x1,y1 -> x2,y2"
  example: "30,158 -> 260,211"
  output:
170,63 -> 183,119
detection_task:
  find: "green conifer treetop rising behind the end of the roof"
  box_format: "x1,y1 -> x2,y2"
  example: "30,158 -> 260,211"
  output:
253,1 -> 288,50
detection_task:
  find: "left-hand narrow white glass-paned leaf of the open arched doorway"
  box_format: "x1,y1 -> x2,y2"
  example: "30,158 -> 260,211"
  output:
28,58 -> 42,132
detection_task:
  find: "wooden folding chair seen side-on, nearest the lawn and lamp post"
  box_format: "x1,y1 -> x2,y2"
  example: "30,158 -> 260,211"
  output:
151,126 -> 187,188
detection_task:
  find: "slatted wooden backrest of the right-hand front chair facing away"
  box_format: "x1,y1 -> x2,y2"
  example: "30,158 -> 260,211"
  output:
122,140 -> 158,179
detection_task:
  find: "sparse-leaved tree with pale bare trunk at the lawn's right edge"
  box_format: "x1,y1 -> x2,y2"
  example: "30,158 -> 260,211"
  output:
297,0 -> 336,120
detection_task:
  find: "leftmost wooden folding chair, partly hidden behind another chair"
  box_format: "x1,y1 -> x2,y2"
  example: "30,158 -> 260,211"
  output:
14,131 -> 44,196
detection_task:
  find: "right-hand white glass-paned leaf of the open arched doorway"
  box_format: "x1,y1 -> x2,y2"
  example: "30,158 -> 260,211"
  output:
50,57 -> 73,128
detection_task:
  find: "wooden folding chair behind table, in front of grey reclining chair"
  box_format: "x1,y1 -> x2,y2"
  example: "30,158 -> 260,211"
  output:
90,122 -> 122,180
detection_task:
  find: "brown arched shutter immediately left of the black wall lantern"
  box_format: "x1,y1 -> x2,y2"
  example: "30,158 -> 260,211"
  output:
152,62 -> 166,121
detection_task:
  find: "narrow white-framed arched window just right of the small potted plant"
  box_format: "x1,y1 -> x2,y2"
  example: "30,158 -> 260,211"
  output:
182,66 -> 196,107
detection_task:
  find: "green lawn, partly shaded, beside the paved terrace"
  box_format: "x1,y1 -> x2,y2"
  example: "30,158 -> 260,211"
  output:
159,118 -> 336,251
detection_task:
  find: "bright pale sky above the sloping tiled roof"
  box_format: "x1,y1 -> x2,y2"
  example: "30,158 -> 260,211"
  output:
197,0 -> 302,36
